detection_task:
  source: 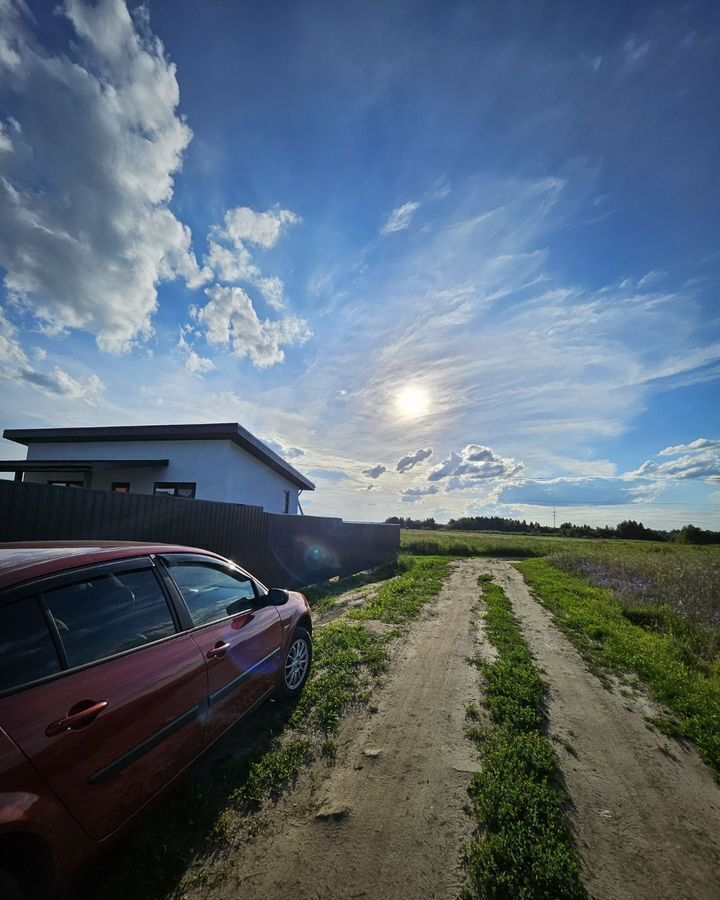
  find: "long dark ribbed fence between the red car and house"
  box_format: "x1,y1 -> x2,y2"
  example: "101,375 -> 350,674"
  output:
0,480 -> 400,587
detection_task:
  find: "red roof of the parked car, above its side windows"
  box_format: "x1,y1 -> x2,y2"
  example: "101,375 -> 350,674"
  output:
0,541 -> 223,590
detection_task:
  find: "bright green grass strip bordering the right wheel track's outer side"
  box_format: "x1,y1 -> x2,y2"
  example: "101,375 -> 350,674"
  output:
518,560 -> 720,773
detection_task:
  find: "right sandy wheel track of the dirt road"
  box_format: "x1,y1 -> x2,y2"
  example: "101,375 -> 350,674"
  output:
481,560 -> 720,900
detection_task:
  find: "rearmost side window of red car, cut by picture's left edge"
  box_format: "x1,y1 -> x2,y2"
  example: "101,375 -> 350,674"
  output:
0,597 -> 60,691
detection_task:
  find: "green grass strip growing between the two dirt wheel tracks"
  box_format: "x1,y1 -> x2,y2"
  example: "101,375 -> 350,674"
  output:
465,576 -> 587,900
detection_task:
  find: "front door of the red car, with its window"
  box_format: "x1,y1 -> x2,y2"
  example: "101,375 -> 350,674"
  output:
162,554 -> 283,742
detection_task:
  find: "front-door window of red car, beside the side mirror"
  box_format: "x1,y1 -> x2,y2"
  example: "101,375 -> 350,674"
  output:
167,558 -> 256,625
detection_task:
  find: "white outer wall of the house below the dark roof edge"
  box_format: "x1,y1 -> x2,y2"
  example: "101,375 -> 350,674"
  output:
24,440 -> 298,515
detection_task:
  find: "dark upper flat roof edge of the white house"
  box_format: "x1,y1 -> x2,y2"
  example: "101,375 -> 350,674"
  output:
3,422 -> 315,491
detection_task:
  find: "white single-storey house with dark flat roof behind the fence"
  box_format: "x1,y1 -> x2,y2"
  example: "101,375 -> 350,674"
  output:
0,422 -> 315,515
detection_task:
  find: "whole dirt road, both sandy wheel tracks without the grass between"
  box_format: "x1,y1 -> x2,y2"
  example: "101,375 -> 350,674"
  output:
184,559 -> 720,900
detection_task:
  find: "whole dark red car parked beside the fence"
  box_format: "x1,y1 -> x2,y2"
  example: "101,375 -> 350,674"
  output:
0,542 -> 312,900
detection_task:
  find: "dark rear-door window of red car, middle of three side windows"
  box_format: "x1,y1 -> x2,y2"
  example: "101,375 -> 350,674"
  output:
43,568 -> 176,667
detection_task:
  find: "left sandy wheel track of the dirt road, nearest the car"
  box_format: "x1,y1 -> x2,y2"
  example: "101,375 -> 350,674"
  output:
195,560 -> 482,900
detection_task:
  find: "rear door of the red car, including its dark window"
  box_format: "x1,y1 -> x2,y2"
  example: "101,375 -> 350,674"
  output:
0,558 -> 207,840
